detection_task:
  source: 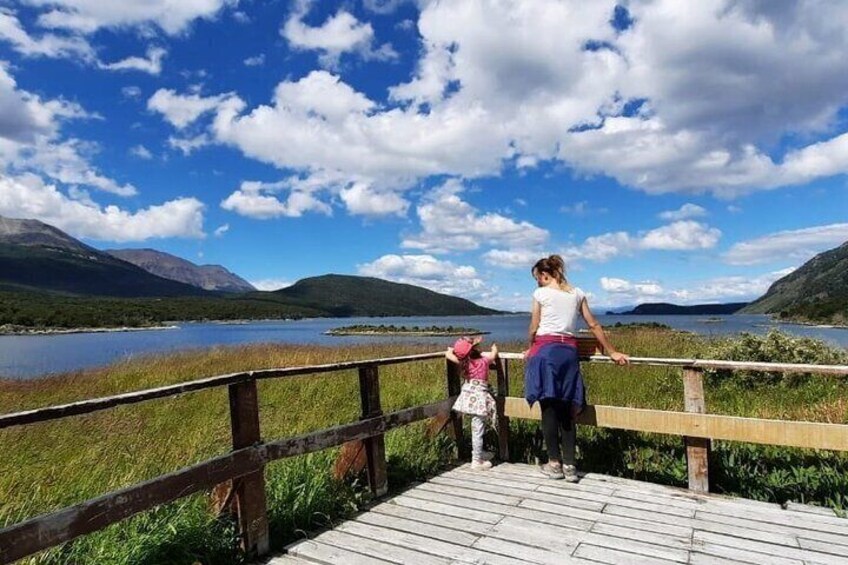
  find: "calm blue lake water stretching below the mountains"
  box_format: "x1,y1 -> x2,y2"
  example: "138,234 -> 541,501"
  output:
0,315 -> 848,379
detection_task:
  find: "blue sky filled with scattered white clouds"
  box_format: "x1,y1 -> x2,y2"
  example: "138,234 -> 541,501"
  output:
0,0 -> 848,309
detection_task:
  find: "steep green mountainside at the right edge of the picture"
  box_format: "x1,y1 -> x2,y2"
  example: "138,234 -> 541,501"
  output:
743,241 -> 848,325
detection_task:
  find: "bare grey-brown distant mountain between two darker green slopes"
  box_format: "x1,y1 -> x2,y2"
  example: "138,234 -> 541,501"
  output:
106,249 -> 256,292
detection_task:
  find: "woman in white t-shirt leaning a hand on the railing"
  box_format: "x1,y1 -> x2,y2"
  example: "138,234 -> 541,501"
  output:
524,255 -> 630,482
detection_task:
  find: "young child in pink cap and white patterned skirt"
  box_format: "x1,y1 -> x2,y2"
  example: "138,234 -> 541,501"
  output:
445,337 -> 498,471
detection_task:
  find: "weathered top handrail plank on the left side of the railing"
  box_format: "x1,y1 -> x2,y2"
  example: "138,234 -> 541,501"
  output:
0,353 -> 444,429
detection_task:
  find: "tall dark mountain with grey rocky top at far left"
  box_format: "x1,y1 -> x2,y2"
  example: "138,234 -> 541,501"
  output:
0,216 -> 203,296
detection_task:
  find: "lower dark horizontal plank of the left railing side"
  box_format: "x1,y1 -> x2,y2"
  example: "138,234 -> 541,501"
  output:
0,399 -> 452,563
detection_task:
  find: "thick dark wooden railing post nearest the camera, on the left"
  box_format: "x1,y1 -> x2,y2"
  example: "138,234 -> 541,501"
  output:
229,380 -> 270,556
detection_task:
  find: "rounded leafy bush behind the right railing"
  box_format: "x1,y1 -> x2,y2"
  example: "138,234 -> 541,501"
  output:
705,330 -> 848,387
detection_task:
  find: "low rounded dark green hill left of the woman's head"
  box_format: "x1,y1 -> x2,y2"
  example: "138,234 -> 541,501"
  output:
270,275 -> 499,317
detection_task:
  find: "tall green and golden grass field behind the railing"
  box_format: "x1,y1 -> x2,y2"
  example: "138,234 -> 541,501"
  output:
0,329 -> 848,565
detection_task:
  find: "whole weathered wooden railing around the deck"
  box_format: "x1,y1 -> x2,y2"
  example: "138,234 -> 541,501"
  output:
0,338 -> 848,564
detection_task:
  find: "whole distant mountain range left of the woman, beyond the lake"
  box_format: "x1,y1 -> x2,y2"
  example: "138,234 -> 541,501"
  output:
0,216 -> 498,327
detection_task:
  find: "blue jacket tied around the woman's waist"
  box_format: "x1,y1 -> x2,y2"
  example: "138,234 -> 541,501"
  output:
524,343 -> 586,412
